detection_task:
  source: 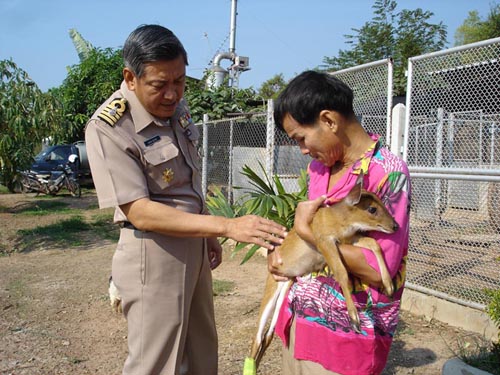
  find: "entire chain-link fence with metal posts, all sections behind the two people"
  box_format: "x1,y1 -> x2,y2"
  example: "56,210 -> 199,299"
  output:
198,38 -> 500,309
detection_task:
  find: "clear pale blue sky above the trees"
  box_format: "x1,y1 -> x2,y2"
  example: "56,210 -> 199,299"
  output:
0,0 -> 492,91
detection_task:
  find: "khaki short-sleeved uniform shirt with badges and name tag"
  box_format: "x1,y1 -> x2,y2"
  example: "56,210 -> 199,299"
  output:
85,82 -> 205,222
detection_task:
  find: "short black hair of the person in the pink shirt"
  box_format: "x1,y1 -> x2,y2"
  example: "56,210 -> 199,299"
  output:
274,70 -> 354,130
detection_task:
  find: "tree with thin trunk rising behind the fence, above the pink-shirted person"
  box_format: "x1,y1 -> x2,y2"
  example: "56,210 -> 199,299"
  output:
321,0 -> 447,95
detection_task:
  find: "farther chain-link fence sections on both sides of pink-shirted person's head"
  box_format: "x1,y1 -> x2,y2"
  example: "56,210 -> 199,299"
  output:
198,59 -> 392,202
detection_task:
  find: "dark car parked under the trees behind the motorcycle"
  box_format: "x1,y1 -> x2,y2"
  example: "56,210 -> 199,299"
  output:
30,141 -> 92,184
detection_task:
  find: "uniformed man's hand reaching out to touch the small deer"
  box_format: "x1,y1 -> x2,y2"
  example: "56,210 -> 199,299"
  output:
224,215 -> 287,250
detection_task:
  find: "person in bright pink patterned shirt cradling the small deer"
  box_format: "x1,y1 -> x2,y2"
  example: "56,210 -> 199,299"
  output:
268,71 -> 411,375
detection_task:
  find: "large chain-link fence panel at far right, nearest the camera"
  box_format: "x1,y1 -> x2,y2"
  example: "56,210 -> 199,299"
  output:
404,38 -> 500,308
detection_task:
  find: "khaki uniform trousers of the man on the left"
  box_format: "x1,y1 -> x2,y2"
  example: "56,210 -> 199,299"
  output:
112,228 -> 218,375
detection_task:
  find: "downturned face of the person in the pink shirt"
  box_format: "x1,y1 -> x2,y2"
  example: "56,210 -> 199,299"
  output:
283,114 -> 342,167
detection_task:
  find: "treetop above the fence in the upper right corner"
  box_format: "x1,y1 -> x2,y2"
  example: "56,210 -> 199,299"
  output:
455,4 -> 500,46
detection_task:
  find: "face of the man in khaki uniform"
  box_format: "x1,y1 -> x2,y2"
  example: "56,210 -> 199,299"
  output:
124,56 -> 186,119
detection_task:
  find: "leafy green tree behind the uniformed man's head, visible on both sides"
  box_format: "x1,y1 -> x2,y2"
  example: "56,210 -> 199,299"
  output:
51,48 -> 266,137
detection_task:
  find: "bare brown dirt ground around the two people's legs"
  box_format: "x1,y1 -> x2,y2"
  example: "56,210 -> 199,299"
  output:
0,192 -> 486,375
